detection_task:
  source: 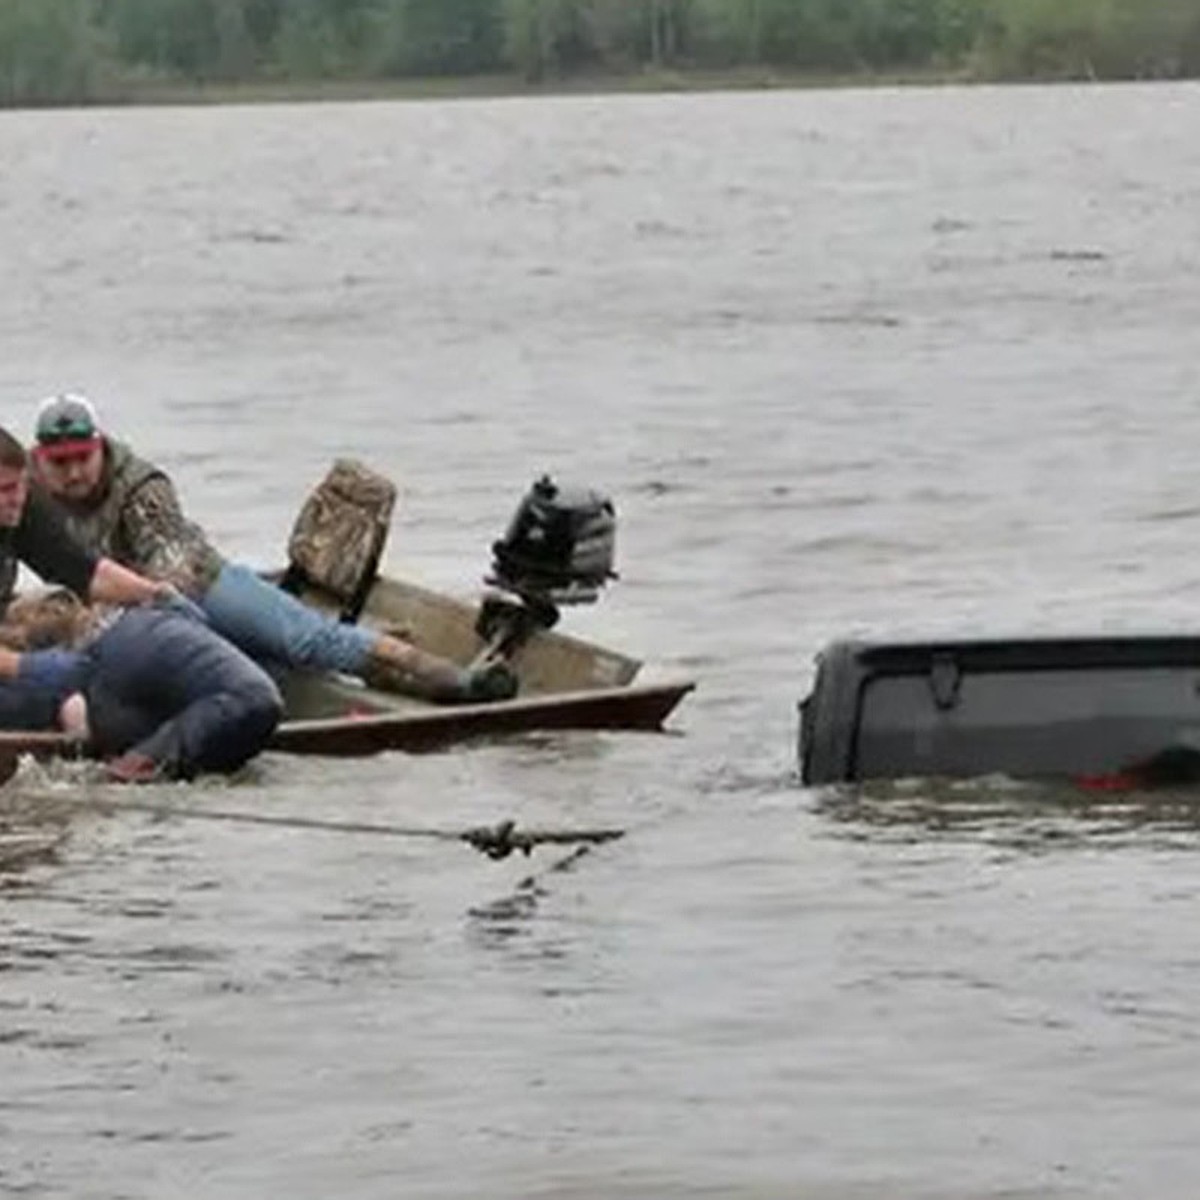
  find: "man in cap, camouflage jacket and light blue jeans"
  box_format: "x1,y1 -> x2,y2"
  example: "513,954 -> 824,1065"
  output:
34,394 -> 517,703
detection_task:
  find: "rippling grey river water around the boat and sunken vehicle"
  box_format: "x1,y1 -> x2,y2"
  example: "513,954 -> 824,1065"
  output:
0,85 -> 1200,1200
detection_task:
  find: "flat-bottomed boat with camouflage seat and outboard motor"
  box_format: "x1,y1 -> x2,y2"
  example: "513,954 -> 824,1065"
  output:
0,460 -> 695,779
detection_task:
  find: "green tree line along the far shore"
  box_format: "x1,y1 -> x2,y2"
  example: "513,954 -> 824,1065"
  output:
0,0 -> 1200,106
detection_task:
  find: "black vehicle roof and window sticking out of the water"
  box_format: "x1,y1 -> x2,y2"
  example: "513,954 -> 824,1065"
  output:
799,635 -> 1200,787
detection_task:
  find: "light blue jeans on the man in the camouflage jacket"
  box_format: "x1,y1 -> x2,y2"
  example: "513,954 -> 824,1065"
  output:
197,563 -> 378,674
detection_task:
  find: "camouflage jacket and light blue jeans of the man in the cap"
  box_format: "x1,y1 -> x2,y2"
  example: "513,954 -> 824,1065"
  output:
45,438 -> 377,674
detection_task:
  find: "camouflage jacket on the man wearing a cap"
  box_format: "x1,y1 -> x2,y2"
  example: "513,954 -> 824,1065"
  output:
52,438 -> 223,598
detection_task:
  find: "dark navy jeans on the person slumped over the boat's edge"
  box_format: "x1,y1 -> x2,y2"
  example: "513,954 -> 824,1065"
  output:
84,608 -> 283,779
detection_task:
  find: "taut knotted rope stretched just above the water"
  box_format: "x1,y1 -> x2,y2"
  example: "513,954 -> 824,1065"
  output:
14,792 -> 625,862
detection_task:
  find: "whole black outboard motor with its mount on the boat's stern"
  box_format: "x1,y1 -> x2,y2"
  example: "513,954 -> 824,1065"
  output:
475,475 -> 617,661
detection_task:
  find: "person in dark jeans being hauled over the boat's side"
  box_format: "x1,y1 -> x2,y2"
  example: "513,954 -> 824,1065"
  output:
0,590 -> 283,784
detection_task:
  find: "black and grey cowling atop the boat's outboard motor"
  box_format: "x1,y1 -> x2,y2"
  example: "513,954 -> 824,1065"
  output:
492,475 -> 617,604
